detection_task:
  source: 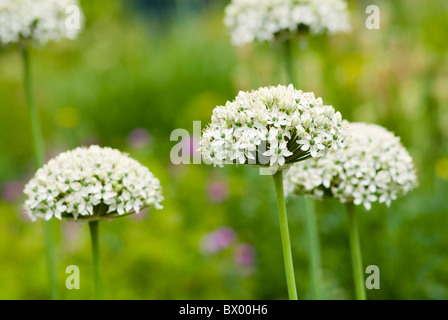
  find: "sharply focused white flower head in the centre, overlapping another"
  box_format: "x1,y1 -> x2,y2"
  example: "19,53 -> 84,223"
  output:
201,85 -> 346,170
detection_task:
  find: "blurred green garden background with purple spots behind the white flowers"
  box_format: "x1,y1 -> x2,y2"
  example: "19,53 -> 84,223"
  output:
0,0 -> 448,299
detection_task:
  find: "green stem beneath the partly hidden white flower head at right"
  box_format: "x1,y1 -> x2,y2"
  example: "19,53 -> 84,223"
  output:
346,203 -> 366,300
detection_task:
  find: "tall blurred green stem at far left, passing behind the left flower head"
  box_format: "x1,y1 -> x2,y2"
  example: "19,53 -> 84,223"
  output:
20,45 -> 58,300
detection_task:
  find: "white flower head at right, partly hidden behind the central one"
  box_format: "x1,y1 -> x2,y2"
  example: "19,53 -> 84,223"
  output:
285,123 -> 417,210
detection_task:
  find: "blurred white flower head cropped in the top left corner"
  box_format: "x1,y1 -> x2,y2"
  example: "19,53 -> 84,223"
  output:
0,0 -> 80,45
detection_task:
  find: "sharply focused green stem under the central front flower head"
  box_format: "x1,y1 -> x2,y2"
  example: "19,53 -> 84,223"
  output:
273,171 -> 297,300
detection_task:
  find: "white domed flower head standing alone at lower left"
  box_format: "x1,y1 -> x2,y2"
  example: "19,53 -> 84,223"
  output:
24,146 -> 163,221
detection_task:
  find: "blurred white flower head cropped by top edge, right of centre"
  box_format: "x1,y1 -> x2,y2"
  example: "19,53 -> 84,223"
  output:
224,0 -> 350,45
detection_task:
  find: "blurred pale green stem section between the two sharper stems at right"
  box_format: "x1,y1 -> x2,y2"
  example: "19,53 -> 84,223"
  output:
304,198 -> 322,300
